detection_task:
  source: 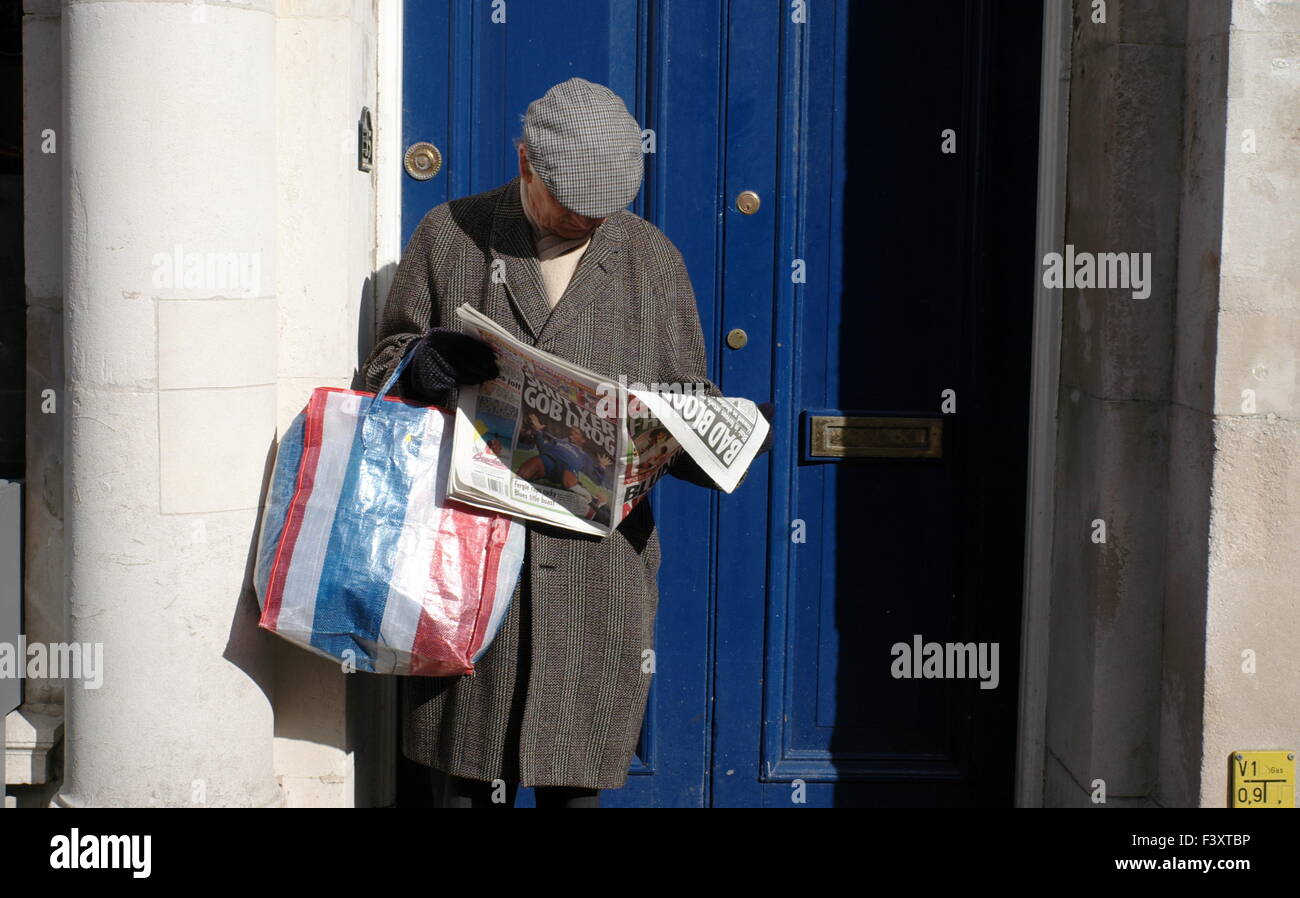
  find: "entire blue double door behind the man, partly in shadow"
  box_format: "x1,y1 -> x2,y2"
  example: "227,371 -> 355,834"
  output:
403,0 -> 1039,807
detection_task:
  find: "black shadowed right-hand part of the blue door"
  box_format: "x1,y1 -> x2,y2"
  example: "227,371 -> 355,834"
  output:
832,0 -> 1041,807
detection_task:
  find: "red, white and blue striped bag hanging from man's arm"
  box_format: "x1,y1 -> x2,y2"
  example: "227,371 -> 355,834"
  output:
254,343 -> 524,677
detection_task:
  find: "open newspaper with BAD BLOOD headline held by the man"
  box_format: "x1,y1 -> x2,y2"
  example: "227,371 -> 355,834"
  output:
447,305 -> 768,537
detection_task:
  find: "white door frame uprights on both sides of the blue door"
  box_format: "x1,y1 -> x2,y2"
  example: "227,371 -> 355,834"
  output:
371,0 -> 1073,807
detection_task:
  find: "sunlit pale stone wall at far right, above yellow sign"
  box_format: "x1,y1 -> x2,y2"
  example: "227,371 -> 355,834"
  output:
1195,0 -> 1300,807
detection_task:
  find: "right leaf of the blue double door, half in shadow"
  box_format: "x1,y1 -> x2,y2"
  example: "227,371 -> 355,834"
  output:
712,1 -> 1040,807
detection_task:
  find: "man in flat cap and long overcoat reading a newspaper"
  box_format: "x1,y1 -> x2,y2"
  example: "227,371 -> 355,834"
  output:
365,78 -> 767,807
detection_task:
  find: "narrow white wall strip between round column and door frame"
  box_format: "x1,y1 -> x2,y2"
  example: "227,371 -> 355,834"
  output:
274,0 -> 377,807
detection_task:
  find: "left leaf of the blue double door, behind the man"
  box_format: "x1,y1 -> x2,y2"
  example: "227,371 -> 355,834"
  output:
402,0 -> 722,807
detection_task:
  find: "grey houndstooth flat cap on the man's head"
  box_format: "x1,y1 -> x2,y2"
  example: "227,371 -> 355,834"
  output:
524,78 -> 645,218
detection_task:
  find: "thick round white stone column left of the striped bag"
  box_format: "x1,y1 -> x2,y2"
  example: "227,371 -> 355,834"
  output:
52,0 -> 282,807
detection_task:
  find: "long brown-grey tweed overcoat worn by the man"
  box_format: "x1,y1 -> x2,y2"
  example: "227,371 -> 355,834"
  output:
364,177 -> 720,789
